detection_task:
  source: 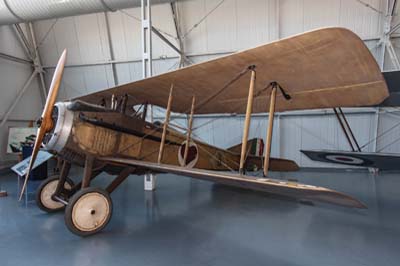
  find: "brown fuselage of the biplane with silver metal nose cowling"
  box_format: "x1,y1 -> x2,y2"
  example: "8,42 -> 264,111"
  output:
45,102 -> 250,170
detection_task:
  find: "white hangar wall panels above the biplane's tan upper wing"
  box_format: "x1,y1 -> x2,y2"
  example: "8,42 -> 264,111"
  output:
35,0 -> 384,99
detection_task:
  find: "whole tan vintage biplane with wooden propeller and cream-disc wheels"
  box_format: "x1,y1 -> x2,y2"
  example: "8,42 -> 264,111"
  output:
21,28 -> 388,236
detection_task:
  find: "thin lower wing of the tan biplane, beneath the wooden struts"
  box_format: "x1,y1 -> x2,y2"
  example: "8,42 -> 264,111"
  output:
99,157 -> 366,208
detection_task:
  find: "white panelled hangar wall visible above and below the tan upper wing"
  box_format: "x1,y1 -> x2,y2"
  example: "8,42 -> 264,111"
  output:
0,0 -> 400,166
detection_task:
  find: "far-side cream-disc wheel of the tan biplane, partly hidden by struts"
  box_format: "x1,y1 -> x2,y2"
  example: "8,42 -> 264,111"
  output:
35,175 -> 74,213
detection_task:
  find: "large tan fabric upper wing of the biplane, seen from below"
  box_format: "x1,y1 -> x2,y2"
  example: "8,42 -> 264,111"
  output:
79,28 -> 388,114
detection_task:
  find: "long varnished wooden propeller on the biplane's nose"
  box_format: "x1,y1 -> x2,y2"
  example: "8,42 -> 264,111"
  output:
19,50 -> 67,200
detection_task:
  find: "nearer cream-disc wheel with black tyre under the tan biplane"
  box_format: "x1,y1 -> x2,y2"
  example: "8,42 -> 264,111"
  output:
65,187 -> 113,236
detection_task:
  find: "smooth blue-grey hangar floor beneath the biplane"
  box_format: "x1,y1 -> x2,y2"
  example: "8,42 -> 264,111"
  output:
0,170 -> 400,266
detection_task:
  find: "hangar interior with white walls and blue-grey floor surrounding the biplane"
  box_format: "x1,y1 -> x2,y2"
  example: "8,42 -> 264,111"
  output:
0,0 -> 400,265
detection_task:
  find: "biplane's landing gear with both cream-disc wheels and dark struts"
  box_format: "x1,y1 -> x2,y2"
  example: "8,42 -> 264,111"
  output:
36,156 -> 132,237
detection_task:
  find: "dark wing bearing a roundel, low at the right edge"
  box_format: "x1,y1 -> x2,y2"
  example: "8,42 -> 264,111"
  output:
301,150 -> 400,170
